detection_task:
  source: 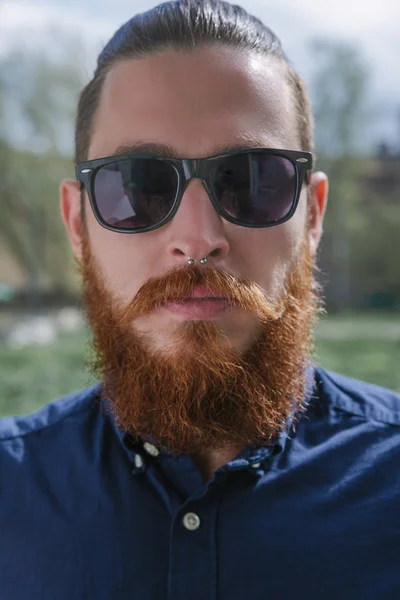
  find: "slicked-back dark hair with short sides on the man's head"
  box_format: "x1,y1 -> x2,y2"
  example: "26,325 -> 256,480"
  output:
75,0 -> 314,162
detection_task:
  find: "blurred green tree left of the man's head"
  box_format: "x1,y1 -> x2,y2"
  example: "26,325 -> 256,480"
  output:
0,39 -> 83,304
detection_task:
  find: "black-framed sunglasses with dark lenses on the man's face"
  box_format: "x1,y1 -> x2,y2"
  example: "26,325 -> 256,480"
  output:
75,148 -> 312,233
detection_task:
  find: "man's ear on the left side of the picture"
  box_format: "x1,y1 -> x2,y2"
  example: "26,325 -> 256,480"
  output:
60,179 -> 84,260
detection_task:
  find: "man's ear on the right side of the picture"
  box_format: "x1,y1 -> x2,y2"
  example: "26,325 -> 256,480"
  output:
308,171 -> 329,255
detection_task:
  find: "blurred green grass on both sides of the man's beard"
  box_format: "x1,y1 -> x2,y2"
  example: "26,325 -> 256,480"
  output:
0,317 -> 400,417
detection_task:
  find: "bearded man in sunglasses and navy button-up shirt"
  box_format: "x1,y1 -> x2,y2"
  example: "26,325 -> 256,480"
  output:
0,0 -> 400,600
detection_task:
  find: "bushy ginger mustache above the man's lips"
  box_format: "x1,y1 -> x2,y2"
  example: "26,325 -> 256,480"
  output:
121,265 -> 286,324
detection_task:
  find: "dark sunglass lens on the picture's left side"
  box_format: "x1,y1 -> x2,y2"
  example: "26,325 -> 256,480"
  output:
94,158 -> 178,230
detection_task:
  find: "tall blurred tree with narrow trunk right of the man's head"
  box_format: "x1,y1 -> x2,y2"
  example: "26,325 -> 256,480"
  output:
311,40 -> 369,310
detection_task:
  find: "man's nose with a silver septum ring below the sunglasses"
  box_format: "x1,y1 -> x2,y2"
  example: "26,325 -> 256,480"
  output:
167,179 -> 230,266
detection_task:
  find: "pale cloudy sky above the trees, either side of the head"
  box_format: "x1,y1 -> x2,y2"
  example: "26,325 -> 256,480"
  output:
0,0 -> 400,146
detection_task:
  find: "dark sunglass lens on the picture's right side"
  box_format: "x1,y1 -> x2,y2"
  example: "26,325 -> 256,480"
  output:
213,152 -> 296,225
